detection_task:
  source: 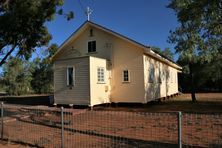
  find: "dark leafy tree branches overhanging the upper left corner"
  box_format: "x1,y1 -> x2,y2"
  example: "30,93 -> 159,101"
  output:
0,0 -> 73,66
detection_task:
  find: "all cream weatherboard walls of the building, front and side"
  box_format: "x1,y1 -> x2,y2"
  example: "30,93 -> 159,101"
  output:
54,22 -> 181,106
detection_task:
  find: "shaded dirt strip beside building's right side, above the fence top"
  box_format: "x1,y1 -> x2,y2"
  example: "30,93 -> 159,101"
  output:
94,93 -> 222,113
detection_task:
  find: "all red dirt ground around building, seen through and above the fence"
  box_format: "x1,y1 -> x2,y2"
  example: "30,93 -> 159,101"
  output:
0,93 -> 222,148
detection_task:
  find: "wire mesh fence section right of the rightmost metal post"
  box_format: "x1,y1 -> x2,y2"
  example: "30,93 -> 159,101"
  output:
182,113 -> 222,148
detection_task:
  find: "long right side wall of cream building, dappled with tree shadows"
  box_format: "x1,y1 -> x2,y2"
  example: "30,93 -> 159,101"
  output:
143,55 -> 178,102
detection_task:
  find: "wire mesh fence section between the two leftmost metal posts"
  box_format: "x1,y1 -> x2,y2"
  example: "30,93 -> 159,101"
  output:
1,105 -> 61,147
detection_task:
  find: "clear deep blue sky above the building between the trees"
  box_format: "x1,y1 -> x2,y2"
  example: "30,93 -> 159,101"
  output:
46,0 -> 178,59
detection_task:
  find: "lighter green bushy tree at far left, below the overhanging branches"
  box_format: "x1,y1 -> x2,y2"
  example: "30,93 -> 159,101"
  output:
2,57 -> 32,95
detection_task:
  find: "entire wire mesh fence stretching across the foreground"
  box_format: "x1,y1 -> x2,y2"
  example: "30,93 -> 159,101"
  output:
0,104 -> 222,148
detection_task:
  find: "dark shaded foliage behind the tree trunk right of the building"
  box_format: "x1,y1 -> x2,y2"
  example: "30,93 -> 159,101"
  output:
178,54 -> 222,92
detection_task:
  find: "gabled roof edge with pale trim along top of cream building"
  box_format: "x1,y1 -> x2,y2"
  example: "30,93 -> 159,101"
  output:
52,21 -> 182,70
